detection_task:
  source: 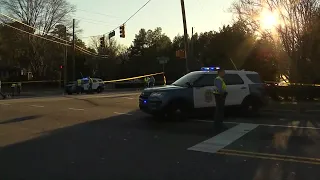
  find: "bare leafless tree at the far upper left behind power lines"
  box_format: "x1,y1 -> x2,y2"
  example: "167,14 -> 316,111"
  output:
0,0 -> 75,77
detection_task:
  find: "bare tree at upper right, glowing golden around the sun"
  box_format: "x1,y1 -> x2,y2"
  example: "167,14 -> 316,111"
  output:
232,0 -> 320,80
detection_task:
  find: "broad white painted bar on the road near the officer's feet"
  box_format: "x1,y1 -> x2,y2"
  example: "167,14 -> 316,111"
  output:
188,123 -> 259,153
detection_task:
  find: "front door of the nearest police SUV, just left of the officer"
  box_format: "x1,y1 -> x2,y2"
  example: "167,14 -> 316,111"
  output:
193,72 -> 217,108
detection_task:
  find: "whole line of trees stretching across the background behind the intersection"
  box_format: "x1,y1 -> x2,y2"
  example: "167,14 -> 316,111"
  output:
0,0 -> 320,83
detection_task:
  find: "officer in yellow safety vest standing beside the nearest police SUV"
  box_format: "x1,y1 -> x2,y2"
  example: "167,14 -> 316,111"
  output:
214,69 -> 228,129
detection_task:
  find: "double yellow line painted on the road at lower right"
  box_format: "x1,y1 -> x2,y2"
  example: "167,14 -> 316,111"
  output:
217,149 -> 320,165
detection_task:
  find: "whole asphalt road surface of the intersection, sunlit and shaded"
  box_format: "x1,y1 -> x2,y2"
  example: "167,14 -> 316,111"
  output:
0,93 -> 320,180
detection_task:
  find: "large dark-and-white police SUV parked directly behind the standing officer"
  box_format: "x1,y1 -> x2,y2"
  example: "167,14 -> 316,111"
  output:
139,67 -> 267,116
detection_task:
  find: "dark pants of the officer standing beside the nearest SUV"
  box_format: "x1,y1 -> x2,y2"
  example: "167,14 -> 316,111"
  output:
214,94 -> 226,127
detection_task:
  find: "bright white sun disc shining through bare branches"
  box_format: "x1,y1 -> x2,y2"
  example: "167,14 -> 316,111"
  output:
259,10 -> 279,30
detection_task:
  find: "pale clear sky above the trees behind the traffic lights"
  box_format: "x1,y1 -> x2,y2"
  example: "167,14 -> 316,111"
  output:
68,0 -> 233,46
